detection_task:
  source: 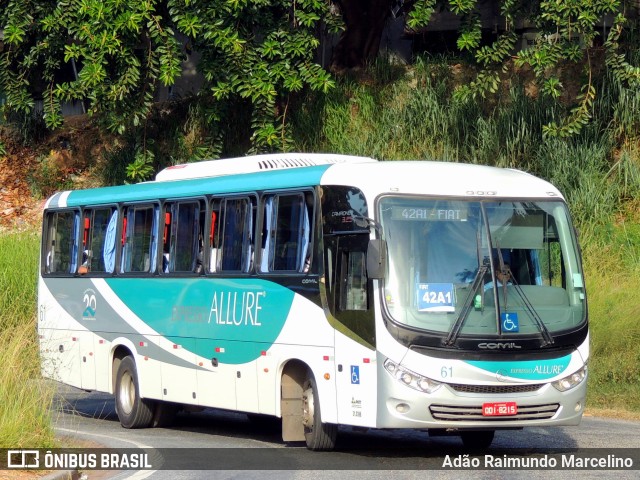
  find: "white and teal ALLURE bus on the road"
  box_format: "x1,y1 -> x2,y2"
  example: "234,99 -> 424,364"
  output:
38,153 -> 589,450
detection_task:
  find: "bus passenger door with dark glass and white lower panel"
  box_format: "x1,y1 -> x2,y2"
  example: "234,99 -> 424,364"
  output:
327,232 -> 377,426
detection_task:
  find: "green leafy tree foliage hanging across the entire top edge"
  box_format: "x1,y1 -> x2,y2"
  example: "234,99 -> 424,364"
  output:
0,0 -> 640,156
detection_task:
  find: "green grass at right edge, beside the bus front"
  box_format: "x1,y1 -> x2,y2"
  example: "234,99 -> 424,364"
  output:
585,212 -> 640,413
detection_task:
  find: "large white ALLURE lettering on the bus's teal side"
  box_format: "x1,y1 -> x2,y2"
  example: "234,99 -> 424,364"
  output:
208,291 -> 267,327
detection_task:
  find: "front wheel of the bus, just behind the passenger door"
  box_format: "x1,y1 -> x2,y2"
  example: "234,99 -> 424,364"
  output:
302,375 -> 338,451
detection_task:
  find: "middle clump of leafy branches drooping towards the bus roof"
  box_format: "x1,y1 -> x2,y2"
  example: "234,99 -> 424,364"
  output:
168,0 -> 335,151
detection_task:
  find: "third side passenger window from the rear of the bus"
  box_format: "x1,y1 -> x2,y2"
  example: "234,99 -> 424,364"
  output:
122,205 -> 157,273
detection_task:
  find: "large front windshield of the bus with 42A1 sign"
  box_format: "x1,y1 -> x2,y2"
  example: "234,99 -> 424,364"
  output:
379,197 -> 585,337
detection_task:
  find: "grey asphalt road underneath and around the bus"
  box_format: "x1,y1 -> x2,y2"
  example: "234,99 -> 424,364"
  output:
50,385 -> 640,480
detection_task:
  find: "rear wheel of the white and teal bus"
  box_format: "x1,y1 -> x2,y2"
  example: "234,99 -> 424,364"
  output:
115,356 -> 154,428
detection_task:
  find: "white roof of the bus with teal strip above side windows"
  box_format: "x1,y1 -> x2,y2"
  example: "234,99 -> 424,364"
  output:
45,158 -> 562,208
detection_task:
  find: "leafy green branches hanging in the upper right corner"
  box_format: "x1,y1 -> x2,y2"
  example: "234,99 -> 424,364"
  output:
408,0 -> 640,137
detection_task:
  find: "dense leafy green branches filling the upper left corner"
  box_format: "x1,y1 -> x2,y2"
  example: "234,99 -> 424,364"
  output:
0,0 -> 180,132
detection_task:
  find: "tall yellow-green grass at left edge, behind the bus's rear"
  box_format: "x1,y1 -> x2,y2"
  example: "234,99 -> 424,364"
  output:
0,232 -> 54,448
